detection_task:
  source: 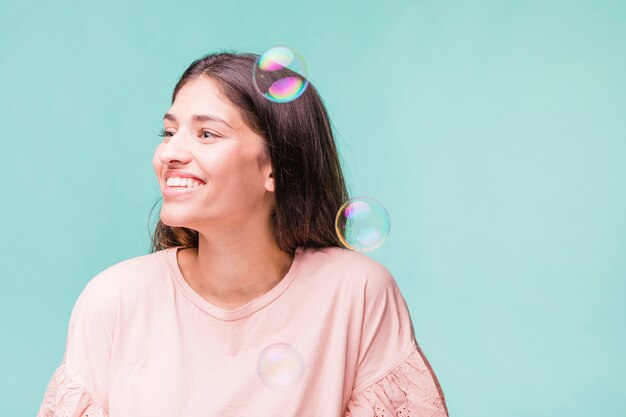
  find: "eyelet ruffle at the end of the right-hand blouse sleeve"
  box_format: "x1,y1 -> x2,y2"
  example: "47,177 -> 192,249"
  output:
345,346 -> 448,417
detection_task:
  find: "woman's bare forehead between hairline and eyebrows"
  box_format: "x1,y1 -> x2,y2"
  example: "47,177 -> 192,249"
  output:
168,76 -> 242,128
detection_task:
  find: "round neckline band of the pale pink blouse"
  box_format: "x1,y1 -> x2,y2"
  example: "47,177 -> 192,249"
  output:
165,246 -> 303,321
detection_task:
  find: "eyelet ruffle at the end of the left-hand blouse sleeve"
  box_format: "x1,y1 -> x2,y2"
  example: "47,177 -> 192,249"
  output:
37,364 -> 109,417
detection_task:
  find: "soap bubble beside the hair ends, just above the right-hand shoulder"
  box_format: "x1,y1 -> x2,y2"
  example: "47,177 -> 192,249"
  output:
335,197 -> 391,252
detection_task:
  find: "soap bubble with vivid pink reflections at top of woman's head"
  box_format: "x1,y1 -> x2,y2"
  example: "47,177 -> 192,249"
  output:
252,46 -> 309,103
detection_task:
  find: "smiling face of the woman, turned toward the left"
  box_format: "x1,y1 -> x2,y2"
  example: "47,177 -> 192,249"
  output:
152,76 -> 274,232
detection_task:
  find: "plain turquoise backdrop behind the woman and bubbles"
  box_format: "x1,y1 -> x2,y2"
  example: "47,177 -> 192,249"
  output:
0,0 -> 626,417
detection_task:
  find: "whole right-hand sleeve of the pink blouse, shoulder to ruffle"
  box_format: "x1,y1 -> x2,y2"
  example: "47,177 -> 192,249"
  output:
344,265 -> 448,417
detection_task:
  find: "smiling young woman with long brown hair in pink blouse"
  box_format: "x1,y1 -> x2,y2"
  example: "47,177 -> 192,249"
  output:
38,53 -> 448,417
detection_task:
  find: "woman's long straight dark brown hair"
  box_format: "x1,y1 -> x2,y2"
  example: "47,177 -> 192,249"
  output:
150,52 -> 349,253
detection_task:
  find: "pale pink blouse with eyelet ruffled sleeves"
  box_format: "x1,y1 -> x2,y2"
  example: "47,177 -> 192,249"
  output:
37,247 -> 448,417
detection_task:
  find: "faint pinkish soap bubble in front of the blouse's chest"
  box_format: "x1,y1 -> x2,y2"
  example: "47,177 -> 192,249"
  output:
257,343 -> 304,391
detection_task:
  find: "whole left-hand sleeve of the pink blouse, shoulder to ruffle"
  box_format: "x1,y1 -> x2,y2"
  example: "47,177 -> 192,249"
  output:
37,273 -> 119,417
